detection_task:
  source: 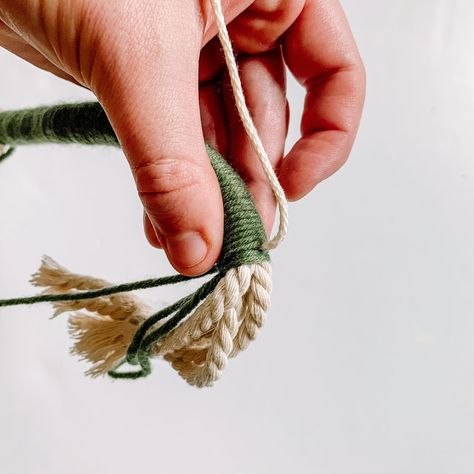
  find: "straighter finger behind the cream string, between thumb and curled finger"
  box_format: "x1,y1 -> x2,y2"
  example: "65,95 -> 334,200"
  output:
223,49 -> 288,235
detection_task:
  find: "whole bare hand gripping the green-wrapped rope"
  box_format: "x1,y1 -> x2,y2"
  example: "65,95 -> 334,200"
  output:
0,0 -> 365,275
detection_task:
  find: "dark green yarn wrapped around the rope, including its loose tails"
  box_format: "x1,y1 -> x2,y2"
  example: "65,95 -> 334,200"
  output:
0,102 -> 269,379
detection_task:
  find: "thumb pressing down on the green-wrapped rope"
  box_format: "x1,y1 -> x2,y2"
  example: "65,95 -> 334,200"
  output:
91,10 -> 224,276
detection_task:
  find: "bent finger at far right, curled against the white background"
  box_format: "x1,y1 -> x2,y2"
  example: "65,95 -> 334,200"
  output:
280,0 -> 365,200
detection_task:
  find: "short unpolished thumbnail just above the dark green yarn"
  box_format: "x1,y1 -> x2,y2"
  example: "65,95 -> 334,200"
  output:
166,232 -> 209,268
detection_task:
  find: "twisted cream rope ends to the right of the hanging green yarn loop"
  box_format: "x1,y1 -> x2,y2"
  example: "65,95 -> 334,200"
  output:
155,262 -> 271,387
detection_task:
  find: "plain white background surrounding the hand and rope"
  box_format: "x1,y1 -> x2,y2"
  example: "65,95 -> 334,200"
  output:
0,0 -> 474,474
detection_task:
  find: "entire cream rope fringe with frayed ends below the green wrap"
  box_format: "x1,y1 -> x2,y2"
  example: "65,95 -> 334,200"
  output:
31,257 -> 272,387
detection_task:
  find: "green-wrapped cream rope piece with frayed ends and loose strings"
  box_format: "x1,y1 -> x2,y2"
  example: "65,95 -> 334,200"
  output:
0,0 -> 288,387
